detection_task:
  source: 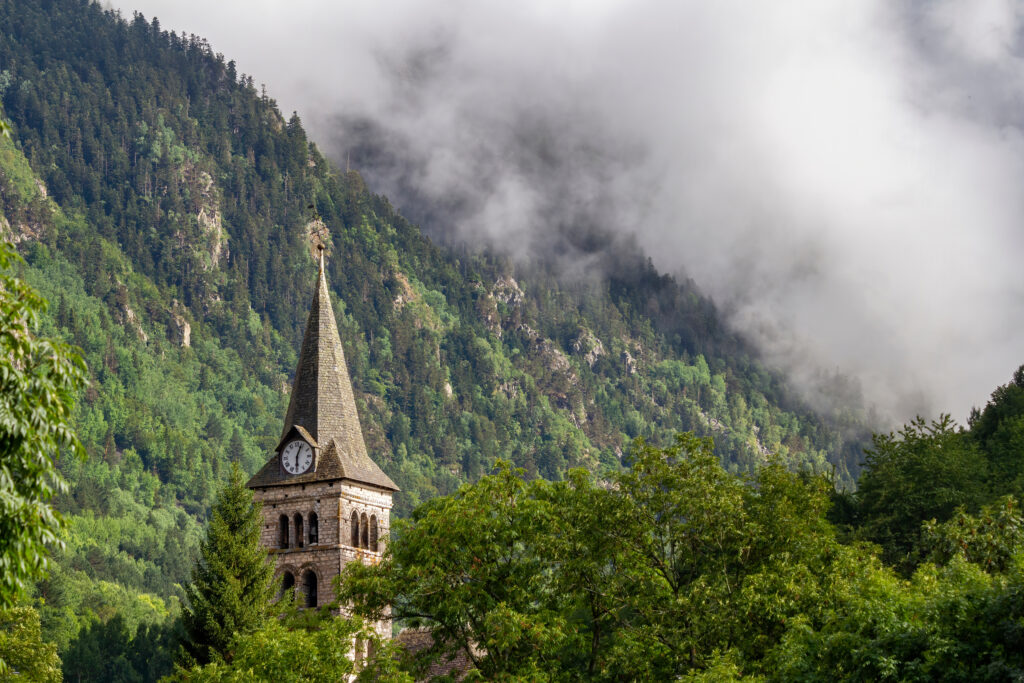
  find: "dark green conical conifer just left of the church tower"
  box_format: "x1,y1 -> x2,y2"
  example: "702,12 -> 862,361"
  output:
182,463 -> 273,665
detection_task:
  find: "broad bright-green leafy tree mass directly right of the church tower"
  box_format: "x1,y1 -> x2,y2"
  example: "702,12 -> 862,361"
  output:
339,434 -> 838,680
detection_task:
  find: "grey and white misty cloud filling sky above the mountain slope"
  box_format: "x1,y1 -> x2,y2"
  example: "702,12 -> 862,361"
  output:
115,0 -> 1024,421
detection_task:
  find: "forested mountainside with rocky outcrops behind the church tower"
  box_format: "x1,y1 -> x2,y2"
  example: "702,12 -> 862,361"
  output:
0,0 -> 863,661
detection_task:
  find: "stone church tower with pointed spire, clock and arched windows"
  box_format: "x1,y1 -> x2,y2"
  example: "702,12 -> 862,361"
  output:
248,250 -> 398,637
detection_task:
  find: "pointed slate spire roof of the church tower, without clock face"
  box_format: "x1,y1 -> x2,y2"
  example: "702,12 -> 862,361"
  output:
248,250 -> 398,490
